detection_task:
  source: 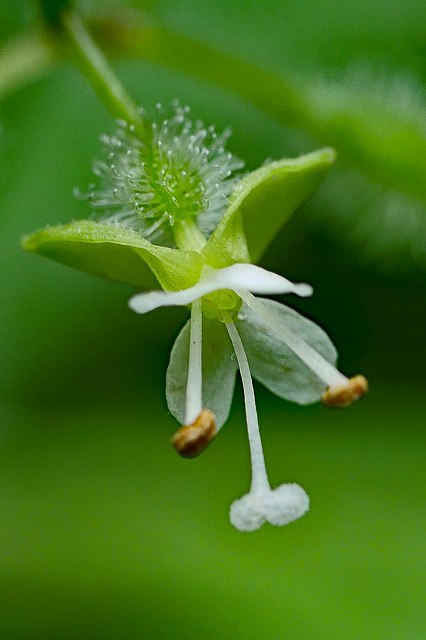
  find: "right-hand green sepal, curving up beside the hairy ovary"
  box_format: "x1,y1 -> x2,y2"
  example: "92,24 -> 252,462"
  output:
203,148 -> 336,268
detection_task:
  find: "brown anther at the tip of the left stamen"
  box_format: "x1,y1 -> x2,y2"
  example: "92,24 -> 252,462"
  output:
172,409 -> 217,458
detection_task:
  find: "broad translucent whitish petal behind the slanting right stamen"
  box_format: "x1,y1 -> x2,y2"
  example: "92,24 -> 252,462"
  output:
236,299 -> 337,404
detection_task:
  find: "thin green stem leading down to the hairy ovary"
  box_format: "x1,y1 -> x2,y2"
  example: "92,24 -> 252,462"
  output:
61,11 -> 151,142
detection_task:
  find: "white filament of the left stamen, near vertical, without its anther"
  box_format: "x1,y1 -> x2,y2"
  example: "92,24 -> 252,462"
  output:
185,299 -> 203,425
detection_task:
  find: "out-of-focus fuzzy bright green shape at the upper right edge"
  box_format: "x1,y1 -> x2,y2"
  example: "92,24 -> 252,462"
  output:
306,65 -> 426,201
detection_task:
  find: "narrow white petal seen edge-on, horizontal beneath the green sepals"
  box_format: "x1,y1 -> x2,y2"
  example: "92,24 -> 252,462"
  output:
129,264 -> 312,313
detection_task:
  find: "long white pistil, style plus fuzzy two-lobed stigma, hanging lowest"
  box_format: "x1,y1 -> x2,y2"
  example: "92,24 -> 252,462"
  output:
226,323 -> 309,531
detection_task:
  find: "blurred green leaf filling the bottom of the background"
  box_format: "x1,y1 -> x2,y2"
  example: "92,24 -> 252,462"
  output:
0,386 -> 426,640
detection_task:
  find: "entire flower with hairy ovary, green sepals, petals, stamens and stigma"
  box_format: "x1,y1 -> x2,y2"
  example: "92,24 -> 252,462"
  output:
23,103 -> 367,531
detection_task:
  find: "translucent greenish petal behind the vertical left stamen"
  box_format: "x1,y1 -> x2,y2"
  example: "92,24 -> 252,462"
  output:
166,317 -> 237,429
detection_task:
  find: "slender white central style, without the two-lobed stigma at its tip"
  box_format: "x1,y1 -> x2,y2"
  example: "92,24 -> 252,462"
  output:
226,322 -> 270,494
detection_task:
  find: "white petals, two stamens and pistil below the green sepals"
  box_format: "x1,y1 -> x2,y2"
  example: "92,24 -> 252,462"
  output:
129,264 -> 366,531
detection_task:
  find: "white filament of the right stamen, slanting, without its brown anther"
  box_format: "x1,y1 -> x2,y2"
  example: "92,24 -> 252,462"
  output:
238,291 -> 350,389
